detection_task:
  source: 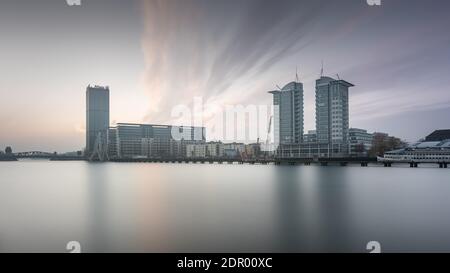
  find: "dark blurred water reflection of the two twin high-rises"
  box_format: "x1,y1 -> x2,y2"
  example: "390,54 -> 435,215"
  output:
274,166 -> 352,252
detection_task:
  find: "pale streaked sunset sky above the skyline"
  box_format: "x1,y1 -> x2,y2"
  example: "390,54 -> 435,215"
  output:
0,0 -> 450,152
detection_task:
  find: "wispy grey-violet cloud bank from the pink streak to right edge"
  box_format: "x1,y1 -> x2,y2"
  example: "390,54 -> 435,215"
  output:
138,0 -> 450,139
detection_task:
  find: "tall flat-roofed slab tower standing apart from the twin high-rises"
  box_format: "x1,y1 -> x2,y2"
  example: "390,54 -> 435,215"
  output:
85,85 -> 109,156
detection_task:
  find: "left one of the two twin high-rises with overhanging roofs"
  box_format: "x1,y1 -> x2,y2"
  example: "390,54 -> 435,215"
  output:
269,82 -> 304,144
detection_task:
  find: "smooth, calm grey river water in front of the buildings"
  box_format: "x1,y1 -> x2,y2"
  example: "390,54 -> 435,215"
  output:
0,160 -> 450,252
